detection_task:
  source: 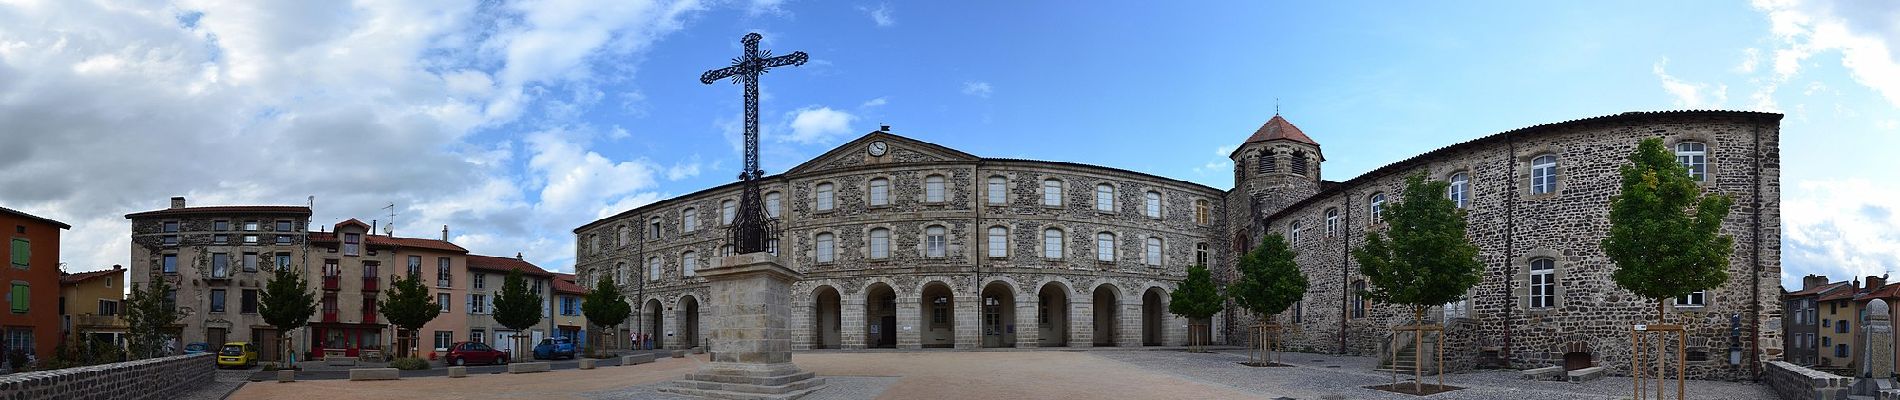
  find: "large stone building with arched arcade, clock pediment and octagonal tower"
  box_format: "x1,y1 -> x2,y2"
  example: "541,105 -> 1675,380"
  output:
574,112 -> 1782,379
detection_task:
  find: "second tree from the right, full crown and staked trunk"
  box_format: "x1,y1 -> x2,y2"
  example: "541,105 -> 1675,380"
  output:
1353,173 -> 1484,391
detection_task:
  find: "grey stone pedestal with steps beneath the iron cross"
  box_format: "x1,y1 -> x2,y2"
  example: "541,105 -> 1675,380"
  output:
659,252 -> 825,398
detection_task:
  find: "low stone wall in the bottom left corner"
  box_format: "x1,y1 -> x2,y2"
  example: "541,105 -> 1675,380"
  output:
0,353 -> 217,400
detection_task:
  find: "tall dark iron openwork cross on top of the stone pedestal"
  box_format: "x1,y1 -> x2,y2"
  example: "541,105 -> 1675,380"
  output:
699,32 -> 806,254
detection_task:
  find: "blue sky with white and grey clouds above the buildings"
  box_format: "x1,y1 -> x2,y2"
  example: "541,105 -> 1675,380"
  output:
0,0 -> 1900,286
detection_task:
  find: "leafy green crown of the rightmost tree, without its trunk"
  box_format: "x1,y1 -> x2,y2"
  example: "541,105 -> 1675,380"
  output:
1602,138 -> 1735,322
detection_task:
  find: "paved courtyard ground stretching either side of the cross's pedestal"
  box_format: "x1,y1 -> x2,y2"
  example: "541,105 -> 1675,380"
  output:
230,349 -> 1775,400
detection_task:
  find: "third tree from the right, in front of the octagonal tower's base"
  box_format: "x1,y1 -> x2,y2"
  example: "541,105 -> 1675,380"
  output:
1227,233 -> 1307,362
